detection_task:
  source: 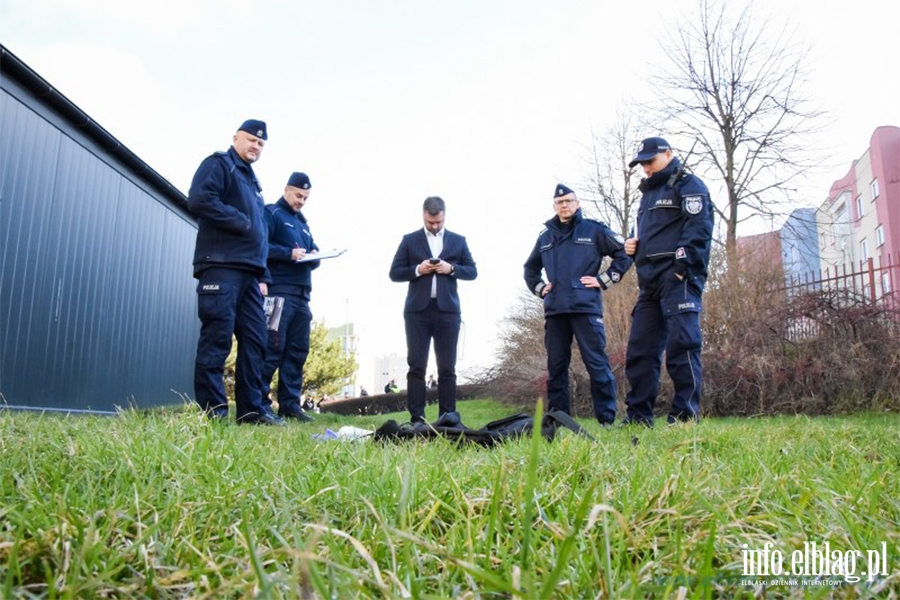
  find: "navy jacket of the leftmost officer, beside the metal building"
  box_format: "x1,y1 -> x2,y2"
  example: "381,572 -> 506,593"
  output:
188,147 -> 268,278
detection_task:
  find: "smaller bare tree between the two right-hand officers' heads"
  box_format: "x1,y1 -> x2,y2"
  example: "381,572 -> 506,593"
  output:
579,110 -> 642,237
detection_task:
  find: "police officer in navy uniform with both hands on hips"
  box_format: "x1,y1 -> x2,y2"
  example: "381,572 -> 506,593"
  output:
525,184 -> 631,425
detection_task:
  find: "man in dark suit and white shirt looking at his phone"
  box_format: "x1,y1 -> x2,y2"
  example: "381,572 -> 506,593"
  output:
390,196 -> 478,423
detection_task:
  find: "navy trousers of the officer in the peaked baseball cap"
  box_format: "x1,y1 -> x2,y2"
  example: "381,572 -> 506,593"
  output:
625,273 -> 703,425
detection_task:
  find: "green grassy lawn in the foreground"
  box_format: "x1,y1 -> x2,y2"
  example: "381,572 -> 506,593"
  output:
0,400 -> 900,598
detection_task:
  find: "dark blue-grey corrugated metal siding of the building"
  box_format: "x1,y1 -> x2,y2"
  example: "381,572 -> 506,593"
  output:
0,85 -> 199,410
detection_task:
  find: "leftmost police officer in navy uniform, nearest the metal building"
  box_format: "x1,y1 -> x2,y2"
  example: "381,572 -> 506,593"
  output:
188,119 -> 284,425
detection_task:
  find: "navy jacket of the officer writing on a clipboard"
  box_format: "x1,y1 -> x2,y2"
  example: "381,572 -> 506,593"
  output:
265,196 -> 320,300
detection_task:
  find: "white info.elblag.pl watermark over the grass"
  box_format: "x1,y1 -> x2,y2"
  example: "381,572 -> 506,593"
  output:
741,542 -> 889,586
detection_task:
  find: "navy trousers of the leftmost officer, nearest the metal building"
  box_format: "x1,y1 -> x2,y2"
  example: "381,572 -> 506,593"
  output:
194,267 -> 266,419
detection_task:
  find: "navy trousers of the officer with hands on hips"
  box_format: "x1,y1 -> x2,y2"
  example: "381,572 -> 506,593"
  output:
544,313 -> 616,425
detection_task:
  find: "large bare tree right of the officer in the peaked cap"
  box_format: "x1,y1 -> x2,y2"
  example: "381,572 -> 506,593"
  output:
650,0 -> 823,260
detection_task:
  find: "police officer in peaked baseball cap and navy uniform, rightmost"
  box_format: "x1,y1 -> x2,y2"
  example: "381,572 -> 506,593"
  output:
625,137 -> 713,426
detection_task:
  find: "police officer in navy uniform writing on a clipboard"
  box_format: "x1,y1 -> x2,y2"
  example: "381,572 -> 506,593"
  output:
263,173 -> 319,421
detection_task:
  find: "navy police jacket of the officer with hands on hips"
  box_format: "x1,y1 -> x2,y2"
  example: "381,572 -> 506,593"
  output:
525,209 -> 631,317
